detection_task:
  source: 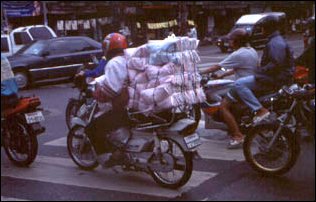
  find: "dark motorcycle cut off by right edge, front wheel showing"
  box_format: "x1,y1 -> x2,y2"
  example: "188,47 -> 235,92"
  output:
243,85 -> 315,175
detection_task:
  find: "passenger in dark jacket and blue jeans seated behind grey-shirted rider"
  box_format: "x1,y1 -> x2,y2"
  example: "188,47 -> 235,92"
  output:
232,15 -> 294,124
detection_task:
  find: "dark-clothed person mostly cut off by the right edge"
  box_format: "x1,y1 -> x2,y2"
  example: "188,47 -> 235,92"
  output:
295,17 -> 315,84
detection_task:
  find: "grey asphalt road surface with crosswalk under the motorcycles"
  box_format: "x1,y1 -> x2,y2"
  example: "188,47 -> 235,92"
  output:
1,34 -> 315,201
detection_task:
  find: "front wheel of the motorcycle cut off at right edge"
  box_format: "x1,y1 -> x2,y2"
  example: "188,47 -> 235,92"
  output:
243,126 -> 300,175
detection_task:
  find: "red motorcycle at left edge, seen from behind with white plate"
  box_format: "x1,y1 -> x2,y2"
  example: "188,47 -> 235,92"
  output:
1,97 -> 45,166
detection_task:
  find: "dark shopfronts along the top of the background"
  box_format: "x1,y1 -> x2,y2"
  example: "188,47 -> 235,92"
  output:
1,1 -> 315,42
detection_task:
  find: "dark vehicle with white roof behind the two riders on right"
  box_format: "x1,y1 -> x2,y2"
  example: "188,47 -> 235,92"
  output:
216,12 -> 286,53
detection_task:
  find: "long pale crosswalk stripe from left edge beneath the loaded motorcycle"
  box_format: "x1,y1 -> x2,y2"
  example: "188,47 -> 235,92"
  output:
1,156 -> 216,198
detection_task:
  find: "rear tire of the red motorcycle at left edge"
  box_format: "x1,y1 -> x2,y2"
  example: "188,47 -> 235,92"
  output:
3,118 -> 38,167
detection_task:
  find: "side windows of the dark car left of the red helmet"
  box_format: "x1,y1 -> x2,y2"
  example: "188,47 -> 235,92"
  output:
49,39 -> 97,55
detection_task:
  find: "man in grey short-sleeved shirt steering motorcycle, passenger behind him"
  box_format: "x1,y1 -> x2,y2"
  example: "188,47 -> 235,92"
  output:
200,28 -> 259,149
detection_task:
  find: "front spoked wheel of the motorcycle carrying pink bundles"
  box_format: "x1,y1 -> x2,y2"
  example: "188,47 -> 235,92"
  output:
67,125 -> 99,170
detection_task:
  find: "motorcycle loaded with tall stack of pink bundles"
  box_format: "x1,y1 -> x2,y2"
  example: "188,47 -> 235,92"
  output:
67,81 -> 201,189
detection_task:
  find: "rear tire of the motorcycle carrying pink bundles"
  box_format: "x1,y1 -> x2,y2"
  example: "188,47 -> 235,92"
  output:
149,137 -> 193,189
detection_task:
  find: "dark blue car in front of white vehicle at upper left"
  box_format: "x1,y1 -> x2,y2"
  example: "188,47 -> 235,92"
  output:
8,37 -> 103,88
